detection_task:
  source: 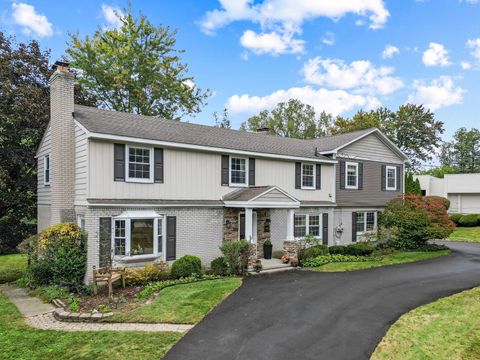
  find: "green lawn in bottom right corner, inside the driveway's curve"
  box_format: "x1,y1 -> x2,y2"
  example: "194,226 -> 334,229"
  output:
371,288 -> 480,360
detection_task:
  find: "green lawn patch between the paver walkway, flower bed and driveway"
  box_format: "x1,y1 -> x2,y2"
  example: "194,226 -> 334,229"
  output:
107,278 -> 242,324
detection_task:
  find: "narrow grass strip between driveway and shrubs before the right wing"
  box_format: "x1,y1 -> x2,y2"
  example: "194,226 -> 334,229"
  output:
305,250 -> 450,272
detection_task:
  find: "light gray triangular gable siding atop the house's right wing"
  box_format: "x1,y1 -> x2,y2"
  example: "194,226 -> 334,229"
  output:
338,134 -> 403,164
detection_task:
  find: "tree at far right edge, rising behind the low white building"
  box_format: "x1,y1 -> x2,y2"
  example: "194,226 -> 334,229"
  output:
440,127 -> 480,173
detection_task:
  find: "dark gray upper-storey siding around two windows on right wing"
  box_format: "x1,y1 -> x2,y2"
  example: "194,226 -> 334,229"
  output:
336,158 -> 404,206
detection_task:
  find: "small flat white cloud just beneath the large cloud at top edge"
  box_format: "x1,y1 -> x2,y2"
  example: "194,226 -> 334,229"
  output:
240,30 -> 305,56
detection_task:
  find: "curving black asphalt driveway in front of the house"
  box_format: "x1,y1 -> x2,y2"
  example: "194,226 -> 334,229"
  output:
166,243 -> 480,360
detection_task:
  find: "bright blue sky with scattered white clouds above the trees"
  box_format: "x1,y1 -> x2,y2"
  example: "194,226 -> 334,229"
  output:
0,0 -> 480,139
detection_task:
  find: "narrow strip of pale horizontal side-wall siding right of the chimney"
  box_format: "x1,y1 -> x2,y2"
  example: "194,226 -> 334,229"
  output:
75,126 -> 88,204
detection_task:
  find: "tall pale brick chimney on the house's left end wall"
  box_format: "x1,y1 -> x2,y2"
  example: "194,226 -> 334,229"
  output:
50,61 -> 75,224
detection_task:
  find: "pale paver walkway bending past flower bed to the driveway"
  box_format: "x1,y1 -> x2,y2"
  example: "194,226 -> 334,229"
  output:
0,285 -> 193,332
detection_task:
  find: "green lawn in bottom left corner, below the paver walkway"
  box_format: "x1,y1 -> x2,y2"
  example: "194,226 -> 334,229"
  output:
0,292 -> 182,360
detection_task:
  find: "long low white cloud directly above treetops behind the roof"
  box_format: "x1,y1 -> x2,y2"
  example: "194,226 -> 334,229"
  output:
226,86 -> 381,116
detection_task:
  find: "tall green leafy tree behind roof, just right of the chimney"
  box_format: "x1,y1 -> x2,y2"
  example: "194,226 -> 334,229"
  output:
67,9 -> 209,120
